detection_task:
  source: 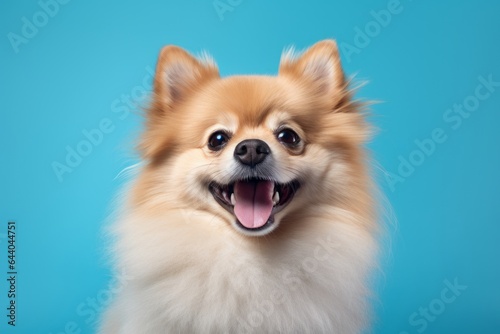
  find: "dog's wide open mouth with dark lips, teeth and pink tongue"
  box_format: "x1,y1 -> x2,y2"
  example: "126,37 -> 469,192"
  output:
209,178 -> 300,231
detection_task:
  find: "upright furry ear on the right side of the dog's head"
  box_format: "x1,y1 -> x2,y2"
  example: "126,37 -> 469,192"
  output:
279,40 -> 346,97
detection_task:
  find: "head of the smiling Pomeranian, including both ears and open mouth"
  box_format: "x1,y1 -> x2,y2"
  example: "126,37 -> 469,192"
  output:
135,41 -> 367,236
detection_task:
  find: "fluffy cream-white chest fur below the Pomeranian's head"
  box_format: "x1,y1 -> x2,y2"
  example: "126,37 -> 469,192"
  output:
101,204 -> 375,334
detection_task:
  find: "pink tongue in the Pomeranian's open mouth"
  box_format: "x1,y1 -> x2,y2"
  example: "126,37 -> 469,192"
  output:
234,181 -> 274,228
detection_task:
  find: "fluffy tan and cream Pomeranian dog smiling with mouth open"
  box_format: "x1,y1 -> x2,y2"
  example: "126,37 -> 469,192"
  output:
100,40 -> 377,334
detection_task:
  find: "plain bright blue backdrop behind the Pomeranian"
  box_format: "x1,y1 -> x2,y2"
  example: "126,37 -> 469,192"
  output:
0,0 -> 500,334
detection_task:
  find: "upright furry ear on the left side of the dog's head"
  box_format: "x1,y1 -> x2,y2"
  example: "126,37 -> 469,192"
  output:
154,45 -> 219,108
